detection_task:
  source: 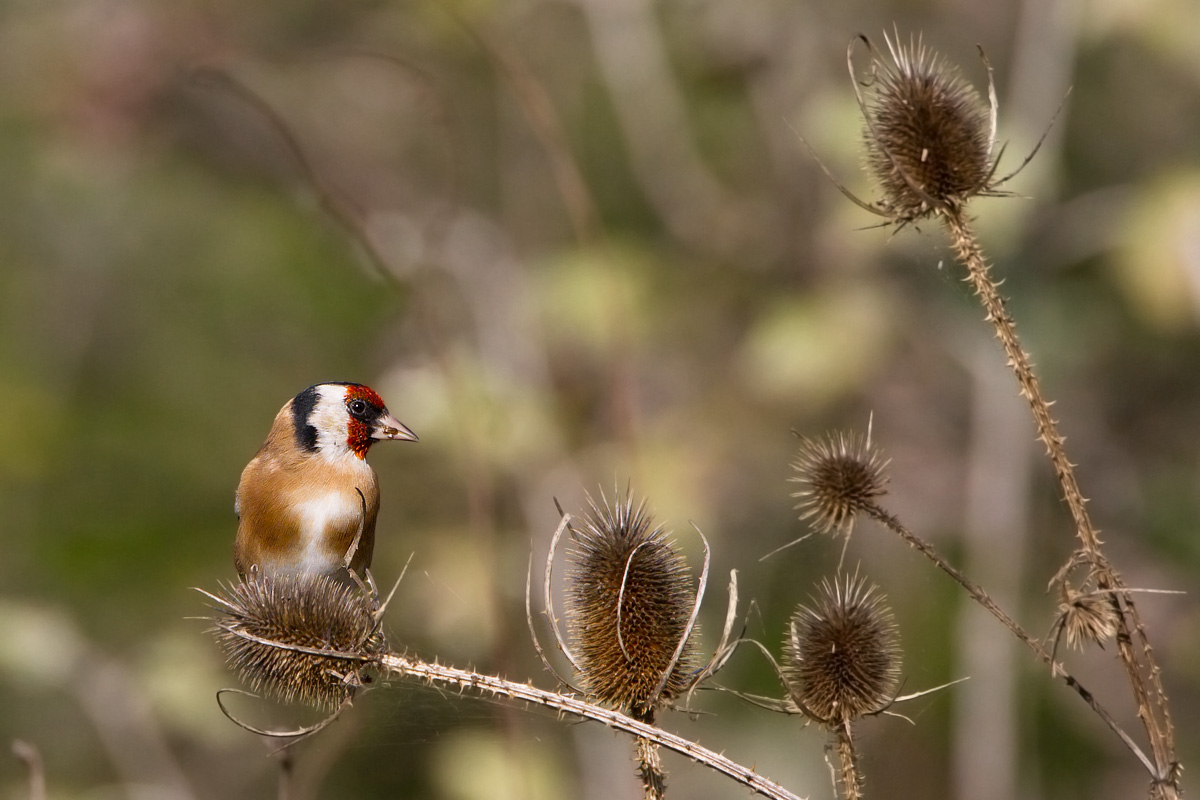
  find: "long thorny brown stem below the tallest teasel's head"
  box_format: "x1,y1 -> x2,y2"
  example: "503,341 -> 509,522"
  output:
942,209 -> 1180,798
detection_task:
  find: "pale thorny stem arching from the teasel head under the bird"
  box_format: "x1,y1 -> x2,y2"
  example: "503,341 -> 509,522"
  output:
379,654 -> 800,800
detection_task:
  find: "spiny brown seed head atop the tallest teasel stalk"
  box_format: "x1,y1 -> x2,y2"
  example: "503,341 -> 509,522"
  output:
856,36 -> 996,223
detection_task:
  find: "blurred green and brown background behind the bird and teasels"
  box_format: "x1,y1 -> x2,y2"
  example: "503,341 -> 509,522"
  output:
0,0 -> 1200,800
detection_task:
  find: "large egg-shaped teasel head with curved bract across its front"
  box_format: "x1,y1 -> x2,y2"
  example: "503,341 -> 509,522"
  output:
565,492 -> 696,721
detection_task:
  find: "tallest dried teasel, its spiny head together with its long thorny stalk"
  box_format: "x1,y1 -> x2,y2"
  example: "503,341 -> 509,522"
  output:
825,31 -> 1180,798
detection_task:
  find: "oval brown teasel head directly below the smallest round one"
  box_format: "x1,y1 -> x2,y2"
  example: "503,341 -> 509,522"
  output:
782,575 -> 900,728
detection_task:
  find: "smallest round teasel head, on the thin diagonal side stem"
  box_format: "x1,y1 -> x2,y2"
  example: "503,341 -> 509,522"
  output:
791,431 -> 889,534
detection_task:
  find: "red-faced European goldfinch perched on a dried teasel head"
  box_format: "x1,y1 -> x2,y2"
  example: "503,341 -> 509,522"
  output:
234,383 -> 416,581
